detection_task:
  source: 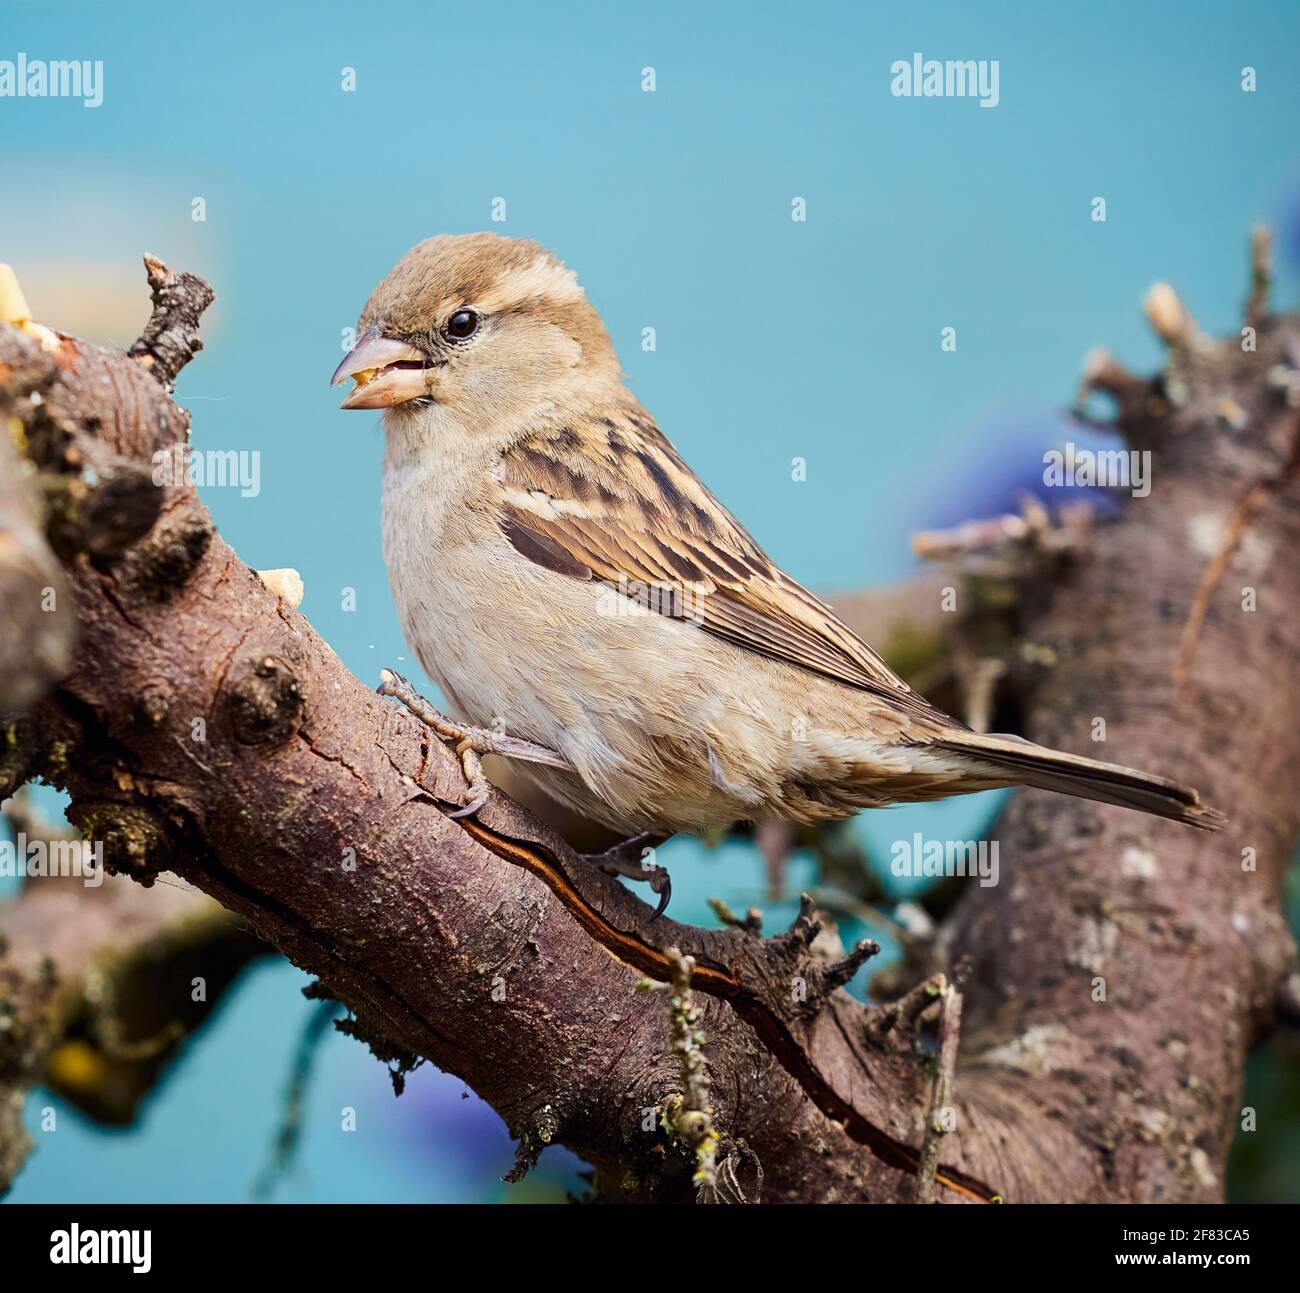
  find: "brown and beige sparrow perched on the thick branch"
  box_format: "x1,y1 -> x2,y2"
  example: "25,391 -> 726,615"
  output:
334,234 -> 1225,910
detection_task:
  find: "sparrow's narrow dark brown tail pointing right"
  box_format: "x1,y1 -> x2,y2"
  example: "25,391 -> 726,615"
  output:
933,730 -> 1227,830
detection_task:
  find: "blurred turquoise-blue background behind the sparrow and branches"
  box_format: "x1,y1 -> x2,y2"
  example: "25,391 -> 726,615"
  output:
0,0 -> 1300,1199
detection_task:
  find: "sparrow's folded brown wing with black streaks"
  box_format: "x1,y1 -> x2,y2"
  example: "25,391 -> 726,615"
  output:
498,404 -> 959,726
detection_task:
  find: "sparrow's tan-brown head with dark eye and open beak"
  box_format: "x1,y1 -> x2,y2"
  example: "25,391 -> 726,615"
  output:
333,234 -> 619,418
